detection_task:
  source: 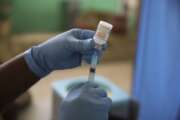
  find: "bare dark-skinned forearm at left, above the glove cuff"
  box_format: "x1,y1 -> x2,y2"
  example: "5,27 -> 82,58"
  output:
0,54 -> 39,111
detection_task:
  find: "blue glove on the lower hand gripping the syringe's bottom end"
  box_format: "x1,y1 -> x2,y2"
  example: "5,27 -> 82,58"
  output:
60,82 -> 112,120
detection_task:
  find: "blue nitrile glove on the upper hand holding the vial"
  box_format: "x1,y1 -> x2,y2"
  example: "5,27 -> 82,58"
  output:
24,29 -> 102,77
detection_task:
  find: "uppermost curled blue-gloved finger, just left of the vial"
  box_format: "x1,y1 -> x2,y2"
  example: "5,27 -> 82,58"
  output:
71,28 -> 95,40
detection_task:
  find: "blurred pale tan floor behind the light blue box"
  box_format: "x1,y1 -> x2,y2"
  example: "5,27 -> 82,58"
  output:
19,62 -> 132,120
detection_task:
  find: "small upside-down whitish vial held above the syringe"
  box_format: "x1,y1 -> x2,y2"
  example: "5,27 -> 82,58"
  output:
93,21 -> 113,45
